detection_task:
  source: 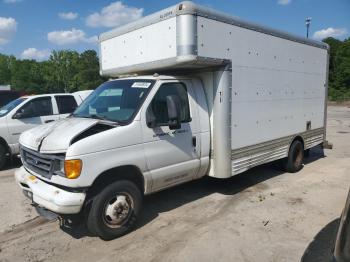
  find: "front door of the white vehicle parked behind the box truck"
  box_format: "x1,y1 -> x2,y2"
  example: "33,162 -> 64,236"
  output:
7,96 -> 59,149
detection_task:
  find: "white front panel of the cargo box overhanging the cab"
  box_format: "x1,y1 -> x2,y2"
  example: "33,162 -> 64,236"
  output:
100,17 -> 177,74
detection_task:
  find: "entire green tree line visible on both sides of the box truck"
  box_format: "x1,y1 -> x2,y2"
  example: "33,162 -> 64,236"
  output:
0,37 -> 350,100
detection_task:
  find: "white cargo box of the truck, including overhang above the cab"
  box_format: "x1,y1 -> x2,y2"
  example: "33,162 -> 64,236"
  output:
100,2 -> 329,177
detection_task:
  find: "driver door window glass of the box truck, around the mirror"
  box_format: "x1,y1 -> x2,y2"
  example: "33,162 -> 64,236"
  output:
150,83 -> 191,126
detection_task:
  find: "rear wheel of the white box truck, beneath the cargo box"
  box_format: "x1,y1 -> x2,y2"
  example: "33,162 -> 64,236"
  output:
284,140 -> 304,173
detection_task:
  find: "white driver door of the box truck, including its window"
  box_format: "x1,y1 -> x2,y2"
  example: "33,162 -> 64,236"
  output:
142,81 -> 200,191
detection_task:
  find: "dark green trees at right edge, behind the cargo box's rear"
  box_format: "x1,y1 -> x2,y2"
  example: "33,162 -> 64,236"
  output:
323,37 -> 350,100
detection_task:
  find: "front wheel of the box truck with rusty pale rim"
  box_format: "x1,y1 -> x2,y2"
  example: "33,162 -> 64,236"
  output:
87,180 -> 142,240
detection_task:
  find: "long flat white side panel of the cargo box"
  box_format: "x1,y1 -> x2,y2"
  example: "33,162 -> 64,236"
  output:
198,17 -> 327,150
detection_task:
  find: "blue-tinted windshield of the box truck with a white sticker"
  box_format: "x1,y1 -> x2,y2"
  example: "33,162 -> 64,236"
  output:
73,79 -> 155,123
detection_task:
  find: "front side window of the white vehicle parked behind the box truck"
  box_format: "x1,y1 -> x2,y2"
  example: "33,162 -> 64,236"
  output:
20,97 -> 53,118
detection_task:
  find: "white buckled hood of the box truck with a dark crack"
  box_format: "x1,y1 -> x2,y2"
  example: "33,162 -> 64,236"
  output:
19,117 -> 100,153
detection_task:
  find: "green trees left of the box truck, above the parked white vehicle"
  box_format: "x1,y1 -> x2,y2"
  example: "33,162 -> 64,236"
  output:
0,50 -> 105,94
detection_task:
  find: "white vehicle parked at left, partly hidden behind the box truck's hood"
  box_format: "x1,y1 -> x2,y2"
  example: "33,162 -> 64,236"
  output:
0,91 -> 92,170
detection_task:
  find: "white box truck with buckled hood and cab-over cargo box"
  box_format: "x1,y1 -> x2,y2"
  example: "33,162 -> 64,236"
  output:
16,2 -> 329,239
